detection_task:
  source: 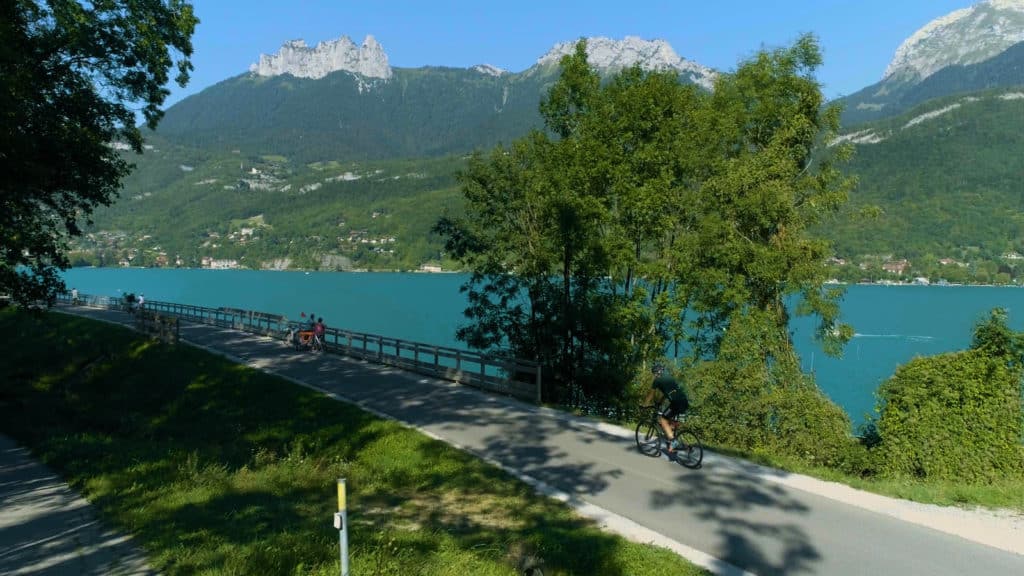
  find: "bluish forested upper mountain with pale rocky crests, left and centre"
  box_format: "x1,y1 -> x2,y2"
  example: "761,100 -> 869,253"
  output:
159,37 -> 715,162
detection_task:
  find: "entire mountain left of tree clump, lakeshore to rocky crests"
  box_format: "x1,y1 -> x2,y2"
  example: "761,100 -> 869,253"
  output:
81,37 -> 715,270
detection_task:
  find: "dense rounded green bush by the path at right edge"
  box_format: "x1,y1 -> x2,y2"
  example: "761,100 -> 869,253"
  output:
876,349 -> 1024,483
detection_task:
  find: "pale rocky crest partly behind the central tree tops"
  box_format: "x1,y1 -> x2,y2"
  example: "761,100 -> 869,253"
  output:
537,35 -> 712,89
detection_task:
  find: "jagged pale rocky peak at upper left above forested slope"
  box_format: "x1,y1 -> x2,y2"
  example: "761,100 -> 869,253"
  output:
249,36 -> 391,79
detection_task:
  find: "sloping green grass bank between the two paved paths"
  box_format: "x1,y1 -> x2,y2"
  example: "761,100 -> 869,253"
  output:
0,308 -> 703,576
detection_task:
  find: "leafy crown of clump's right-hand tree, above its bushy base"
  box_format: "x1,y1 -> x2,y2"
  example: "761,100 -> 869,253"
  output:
679,36 -> 853,359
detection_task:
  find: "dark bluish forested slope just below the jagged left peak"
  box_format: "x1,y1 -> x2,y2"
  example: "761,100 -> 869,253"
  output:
159,68 -> 553,163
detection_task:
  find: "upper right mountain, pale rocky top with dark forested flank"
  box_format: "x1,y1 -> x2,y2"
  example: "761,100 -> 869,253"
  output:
840,0 -> 1024,126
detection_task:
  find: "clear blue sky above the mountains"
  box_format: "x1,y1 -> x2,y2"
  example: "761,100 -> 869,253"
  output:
167,0 -> 975,105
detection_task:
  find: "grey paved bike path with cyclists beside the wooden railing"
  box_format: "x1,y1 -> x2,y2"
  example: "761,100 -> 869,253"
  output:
41,308 -> 1024,576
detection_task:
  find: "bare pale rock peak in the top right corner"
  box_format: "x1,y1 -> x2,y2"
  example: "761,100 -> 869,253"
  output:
883,0 -> 1024,82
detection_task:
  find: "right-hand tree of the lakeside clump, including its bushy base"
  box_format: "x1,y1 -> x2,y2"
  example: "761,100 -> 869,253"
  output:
677,36 -> 853,462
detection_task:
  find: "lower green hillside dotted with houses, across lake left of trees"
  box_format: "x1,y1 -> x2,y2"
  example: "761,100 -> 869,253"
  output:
76,147 -> 464,270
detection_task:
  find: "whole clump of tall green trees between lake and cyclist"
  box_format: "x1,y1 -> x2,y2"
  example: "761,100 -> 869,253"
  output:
435,37 -> 852,463
